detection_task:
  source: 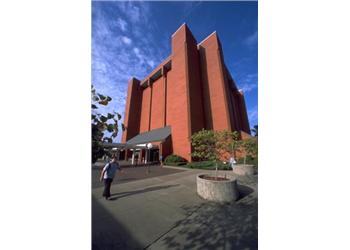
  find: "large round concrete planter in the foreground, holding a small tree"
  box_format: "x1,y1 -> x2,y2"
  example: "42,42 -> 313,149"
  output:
197,174 -> 239,202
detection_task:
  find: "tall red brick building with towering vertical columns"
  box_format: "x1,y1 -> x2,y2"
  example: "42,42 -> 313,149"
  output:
122,24 -> 250,161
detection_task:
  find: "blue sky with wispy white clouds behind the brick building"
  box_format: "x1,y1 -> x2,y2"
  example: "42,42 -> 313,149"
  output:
92,1 -> 258,141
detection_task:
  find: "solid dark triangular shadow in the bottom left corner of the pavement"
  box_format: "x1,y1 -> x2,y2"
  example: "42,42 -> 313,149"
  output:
91,197 -> 143,250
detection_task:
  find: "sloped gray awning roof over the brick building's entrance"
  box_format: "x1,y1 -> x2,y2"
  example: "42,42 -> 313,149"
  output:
126,126 -> 171,144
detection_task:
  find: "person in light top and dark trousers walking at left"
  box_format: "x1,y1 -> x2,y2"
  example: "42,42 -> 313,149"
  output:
100,154 -> 122,200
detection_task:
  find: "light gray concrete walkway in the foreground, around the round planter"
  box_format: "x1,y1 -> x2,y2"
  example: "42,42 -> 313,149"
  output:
92,165 -> 258,250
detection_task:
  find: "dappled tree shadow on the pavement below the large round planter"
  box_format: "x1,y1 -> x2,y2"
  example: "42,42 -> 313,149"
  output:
149,185 -> 258,250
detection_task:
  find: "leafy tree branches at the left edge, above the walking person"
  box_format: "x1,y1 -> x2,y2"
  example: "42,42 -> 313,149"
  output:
91,85 -> 125,163
